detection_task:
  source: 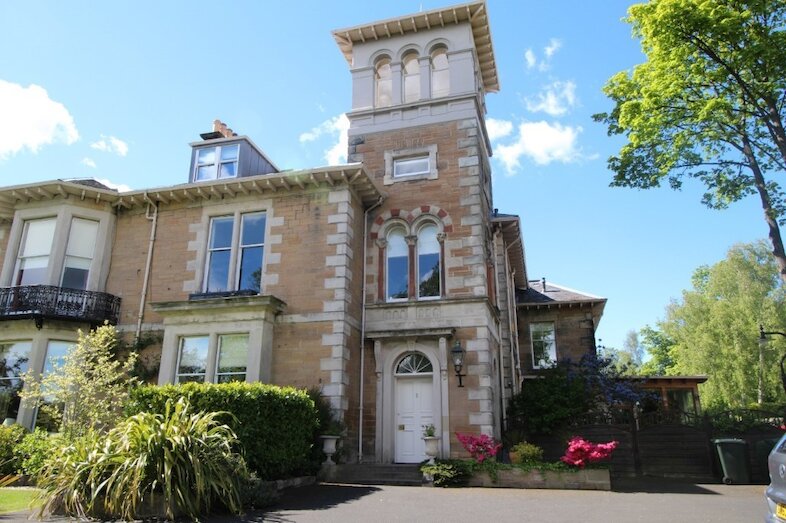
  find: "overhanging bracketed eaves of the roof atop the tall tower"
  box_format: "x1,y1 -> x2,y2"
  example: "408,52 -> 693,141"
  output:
333,2 -> 499,92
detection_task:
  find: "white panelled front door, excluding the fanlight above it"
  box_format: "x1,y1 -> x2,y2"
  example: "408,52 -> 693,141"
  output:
394,376 -> 434,463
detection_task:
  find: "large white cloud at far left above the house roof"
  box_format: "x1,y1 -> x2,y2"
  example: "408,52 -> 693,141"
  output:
0,80 -> 79,160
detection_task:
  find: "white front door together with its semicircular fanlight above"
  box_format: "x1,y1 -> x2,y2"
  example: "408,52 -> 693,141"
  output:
394,352 -> 435,463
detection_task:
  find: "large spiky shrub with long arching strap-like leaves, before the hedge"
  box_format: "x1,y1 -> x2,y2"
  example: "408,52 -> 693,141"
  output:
38,399 -> 248,520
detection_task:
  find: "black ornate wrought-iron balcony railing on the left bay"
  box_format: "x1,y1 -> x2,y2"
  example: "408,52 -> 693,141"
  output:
0,285 -> 120,327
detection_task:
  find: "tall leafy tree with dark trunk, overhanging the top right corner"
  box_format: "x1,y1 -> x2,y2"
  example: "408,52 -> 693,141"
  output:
594,0 -> 786,281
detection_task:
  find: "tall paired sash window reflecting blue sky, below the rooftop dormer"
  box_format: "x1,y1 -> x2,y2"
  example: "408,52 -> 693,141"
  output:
204,212 -> 266,293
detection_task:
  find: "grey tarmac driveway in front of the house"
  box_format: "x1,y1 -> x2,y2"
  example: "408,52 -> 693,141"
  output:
0,481 -> 766,523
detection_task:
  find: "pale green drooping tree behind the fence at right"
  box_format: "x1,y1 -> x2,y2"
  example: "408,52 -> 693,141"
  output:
652,241 -> 786,408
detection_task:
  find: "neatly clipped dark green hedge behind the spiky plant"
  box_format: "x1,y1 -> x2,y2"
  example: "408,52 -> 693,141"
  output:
126,382 -> 318,480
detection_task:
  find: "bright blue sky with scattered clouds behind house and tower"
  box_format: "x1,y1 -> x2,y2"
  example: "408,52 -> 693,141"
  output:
0,0 -> 766,354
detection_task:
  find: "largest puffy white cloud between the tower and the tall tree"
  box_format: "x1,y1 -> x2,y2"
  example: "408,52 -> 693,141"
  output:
494,121 -> 583,175
